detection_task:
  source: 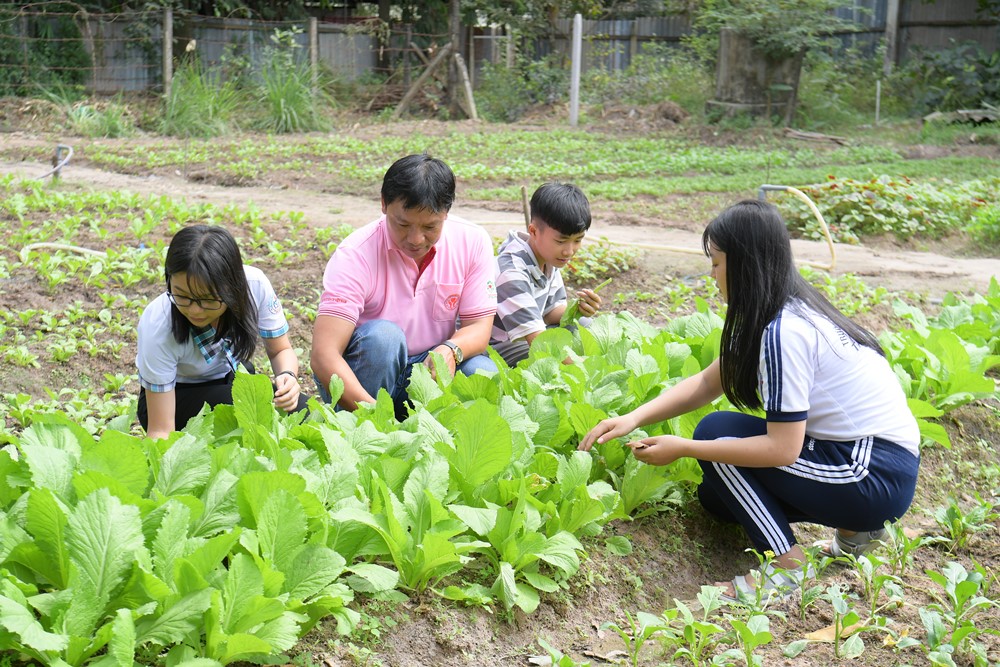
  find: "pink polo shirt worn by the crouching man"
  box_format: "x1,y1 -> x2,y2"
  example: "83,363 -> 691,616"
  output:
318,215 -> 497,356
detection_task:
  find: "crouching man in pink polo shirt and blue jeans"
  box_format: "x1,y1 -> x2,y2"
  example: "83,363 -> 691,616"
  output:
312,154 -> 497,417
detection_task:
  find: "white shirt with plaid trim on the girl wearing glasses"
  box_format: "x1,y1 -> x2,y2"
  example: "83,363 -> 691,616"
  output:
135,266 -> 288,392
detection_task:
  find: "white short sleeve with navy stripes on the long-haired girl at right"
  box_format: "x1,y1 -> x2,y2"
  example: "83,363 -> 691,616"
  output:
758,311 -> 818,422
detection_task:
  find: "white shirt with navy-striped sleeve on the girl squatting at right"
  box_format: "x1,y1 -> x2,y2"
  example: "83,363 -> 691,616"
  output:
757,303 -> 920,456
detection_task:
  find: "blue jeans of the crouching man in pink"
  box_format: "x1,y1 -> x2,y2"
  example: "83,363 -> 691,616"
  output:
316,320 -> 497,417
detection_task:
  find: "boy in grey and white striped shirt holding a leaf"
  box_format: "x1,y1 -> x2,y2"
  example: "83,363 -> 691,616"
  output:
490,183 -> 601,366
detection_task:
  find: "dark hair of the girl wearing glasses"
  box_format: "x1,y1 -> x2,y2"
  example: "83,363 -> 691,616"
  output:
164,225 -> 257,362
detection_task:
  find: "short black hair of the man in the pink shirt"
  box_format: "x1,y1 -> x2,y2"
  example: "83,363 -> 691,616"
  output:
382,153 -> 455,213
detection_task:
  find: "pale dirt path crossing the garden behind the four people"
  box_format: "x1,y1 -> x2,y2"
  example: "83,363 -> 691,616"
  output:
7,162 -> 1000,298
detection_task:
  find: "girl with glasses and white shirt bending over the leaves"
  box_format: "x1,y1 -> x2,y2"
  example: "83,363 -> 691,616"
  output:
135,225 -> 305,439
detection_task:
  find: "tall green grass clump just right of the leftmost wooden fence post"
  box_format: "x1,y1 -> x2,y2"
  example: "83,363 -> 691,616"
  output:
160,58 -> 242,137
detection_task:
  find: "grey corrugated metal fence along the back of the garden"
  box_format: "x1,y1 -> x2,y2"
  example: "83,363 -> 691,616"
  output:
0,0 -> 1000,94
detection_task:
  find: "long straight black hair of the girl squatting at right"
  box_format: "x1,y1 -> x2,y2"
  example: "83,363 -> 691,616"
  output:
701,199 -> 885,410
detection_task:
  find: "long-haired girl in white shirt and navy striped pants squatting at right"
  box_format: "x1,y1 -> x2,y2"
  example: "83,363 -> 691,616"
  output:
580,200 -> 920,599
